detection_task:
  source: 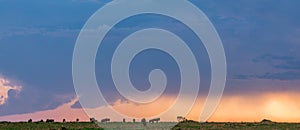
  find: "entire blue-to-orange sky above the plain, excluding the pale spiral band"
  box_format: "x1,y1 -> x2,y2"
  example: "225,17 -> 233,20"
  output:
0,0 -> 300,122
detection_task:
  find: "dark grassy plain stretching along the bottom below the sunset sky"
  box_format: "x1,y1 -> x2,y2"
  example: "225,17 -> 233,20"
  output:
0,121 -> 300,130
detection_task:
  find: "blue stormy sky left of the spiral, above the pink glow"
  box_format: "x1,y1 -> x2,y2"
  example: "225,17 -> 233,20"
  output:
0,0 -> 108,115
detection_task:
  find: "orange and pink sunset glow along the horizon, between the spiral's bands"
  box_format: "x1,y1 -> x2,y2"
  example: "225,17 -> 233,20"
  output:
0,92 -> 300,122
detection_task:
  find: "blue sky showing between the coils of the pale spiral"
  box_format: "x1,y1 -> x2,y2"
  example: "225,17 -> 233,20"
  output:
96,14 -> 211,106
